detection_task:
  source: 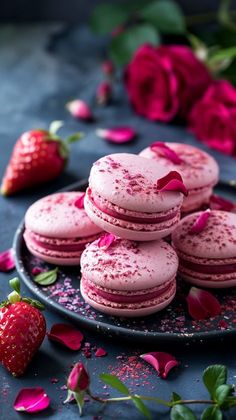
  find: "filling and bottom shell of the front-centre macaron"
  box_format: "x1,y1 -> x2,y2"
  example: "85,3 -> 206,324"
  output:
80,277 -> 176,317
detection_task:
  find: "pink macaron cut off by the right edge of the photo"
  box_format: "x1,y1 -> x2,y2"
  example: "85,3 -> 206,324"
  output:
172,210 -> 236,288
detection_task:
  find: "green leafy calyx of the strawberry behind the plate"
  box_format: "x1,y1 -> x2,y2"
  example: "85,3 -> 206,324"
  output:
45,121 -> 84,160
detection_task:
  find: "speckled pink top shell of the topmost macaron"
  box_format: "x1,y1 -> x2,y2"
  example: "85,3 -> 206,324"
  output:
89,153 -> 183,213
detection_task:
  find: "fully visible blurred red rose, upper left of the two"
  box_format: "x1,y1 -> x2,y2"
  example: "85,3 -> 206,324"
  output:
125,45 -> 212,121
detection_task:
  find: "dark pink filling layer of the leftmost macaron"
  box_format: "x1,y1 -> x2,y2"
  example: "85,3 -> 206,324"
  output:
24,229 -> 99,253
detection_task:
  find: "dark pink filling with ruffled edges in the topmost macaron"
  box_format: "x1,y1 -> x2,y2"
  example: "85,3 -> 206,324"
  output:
87,188 -> 180,224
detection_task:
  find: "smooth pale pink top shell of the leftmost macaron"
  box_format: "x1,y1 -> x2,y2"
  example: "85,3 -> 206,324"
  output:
25,191 -> 101,238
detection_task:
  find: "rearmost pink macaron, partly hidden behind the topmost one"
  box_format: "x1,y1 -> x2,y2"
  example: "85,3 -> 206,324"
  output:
140,142 -> 219,212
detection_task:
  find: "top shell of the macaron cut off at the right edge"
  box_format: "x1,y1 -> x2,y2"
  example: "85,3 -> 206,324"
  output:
172,210 -> 236,259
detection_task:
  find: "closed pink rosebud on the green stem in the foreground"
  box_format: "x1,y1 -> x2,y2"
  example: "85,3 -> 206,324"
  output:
67,362 -> 90,393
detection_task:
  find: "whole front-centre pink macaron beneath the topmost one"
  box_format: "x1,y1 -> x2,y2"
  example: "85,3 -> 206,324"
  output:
81,234 -> 178,317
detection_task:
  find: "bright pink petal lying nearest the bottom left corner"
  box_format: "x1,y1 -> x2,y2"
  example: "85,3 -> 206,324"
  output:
14,387 -> 50,413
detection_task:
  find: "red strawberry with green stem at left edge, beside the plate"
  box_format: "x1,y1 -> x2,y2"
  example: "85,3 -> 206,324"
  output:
0,278 -> 46,376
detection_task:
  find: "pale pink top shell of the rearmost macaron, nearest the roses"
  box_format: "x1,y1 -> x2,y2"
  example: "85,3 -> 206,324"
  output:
139,142 -> 219,189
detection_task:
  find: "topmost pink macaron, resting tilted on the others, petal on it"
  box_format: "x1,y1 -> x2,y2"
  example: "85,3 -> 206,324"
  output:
84,153 -> 187,241
